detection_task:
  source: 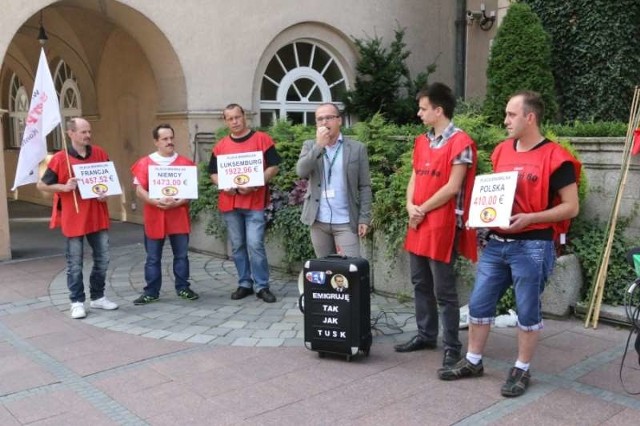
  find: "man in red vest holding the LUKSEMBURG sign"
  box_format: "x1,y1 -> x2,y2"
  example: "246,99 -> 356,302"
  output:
209,104 -> 281,303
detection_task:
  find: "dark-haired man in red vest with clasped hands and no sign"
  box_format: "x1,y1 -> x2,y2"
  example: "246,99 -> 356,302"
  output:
395,83 -> 477,365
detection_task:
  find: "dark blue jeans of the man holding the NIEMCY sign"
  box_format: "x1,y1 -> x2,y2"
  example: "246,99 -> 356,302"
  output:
144,234 -> 189,297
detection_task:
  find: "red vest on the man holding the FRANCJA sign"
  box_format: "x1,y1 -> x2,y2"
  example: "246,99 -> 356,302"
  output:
48,145 -> 110,238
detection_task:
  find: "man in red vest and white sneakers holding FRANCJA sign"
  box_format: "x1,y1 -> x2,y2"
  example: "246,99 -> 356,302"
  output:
37,117 -> 118,319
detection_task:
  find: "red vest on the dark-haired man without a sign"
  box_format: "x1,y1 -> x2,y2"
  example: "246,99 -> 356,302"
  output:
404,131 -> 478,263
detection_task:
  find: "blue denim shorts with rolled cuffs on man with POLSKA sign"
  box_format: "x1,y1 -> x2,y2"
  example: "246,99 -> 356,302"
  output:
469,240 -> 556,331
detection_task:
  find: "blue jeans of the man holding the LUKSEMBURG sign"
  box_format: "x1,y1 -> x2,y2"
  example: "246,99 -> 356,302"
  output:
223,209 -> 269,292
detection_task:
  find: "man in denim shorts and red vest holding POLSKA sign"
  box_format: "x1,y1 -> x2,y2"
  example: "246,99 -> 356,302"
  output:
438,91 -> 580,397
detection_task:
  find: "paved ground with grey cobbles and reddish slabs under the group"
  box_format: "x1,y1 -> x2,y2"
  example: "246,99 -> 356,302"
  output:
0,240 -> 640,425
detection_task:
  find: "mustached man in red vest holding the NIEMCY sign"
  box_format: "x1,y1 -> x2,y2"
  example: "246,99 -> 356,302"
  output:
131,124 -> 199,305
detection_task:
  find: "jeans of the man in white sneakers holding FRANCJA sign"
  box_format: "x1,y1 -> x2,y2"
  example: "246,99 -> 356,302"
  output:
65,229 -> 109,303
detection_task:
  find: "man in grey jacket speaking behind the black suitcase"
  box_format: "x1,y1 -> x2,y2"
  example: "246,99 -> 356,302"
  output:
296,103 -> 372,257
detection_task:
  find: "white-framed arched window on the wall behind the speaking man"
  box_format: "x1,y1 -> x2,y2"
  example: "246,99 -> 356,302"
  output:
260,41 -> 347,126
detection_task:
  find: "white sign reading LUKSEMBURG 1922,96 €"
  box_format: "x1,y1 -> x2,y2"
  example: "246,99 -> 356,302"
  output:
217,151 -> 264,189
